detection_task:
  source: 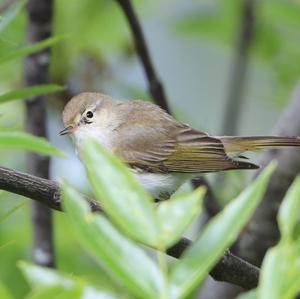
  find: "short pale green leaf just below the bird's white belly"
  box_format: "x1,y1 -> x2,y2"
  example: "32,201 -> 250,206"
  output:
157,188 -> 205,249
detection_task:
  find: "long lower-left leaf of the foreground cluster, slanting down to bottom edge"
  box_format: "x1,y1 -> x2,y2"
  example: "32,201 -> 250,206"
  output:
62,184 -> 163,298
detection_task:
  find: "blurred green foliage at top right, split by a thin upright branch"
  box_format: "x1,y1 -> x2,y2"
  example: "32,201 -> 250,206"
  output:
176,0 -> 300,101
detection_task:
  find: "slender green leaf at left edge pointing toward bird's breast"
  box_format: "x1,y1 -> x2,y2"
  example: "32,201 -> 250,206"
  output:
0,131 -> 64,157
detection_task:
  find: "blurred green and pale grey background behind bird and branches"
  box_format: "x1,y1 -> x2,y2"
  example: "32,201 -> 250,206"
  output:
0,0 -> 300,298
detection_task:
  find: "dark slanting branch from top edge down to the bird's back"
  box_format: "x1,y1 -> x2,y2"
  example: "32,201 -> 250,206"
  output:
117,0 -> 170,112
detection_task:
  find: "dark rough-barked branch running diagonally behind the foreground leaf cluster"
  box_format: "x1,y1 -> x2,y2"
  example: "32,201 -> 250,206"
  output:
0,167 -> 259,289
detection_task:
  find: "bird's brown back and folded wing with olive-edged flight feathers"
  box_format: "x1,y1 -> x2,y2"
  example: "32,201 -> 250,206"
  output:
114,103 -> 257,173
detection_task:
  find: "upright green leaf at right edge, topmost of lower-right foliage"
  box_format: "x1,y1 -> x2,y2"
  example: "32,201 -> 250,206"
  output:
278,176 -> 300,238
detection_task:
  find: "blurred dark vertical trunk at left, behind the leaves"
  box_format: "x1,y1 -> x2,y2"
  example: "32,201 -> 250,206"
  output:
24,0 -> 55,267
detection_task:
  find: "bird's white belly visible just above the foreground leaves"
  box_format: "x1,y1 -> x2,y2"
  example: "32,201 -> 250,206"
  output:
135,173 -> 189,200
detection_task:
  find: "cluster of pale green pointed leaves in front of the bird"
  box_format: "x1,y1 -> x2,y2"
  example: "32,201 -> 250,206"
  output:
47,141 -> 274,298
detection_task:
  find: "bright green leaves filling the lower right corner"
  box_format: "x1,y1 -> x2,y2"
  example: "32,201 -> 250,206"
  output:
239,177 -> 300,299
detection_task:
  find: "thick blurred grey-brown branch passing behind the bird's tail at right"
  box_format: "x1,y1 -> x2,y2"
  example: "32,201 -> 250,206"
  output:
237,83 -> 300,265
